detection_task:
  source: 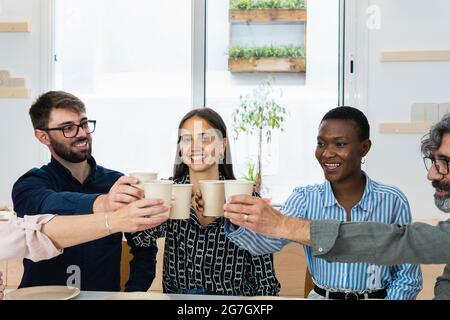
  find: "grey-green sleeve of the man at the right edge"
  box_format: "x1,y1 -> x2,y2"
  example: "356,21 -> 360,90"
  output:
311,220 -> 450,265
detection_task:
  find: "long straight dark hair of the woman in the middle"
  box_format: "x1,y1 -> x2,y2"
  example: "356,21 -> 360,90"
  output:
173,108 -> 236,180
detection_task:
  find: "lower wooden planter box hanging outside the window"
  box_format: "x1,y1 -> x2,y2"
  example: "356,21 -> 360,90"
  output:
228,58 -> 306,73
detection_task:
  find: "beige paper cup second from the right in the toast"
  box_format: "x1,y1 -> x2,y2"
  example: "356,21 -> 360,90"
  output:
199,180 -> 225,217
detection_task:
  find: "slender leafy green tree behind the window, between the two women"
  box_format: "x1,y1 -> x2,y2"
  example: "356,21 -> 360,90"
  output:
233,79 -> 288,192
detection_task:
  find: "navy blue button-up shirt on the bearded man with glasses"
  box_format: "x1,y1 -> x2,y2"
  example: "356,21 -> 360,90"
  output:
12,157 -> 157,291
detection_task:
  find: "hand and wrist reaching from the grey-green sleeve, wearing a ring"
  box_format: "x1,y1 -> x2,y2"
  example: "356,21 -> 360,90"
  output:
224,195 -> 311,245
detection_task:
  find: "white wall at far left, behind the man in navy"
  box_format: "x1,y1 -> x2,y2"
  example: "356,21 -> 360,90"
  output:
0,0 -> 48,205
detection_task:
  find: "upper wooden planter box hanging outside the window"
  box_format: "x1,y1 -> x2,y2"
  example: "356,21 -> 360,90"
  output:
229,9 -> 307,23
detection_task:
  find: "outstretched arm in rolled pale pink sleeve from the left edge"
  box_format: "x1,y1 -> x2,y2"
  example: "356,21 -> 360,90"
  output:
0,200 -> 168,261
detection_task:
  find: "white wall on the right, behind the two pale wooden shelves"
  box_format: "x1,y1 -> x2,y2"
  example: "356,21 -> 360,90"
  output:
356,0 -> 450,219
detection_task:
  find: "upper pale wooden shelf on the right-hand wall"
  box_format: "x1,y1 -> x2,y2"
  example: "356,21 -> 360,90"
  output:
379,50 -> 450,62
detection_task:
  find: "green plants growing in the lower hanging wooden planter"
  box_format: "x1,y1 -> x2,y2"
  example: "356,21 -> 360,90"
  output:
228,45 -> 305,59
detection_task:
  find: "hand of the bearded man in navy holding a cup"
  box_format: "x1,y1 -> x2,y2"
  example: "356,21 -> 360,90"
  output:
93,176 -> 144,213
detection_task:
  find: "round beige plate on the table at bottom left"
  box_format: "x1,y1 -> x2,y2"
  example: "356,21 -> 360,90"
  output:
5,286 -> 80,300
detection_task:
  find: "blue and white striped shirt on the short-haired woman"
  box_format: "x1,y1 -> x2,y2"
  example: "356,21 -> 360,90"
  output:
225,175 -> 422,300
